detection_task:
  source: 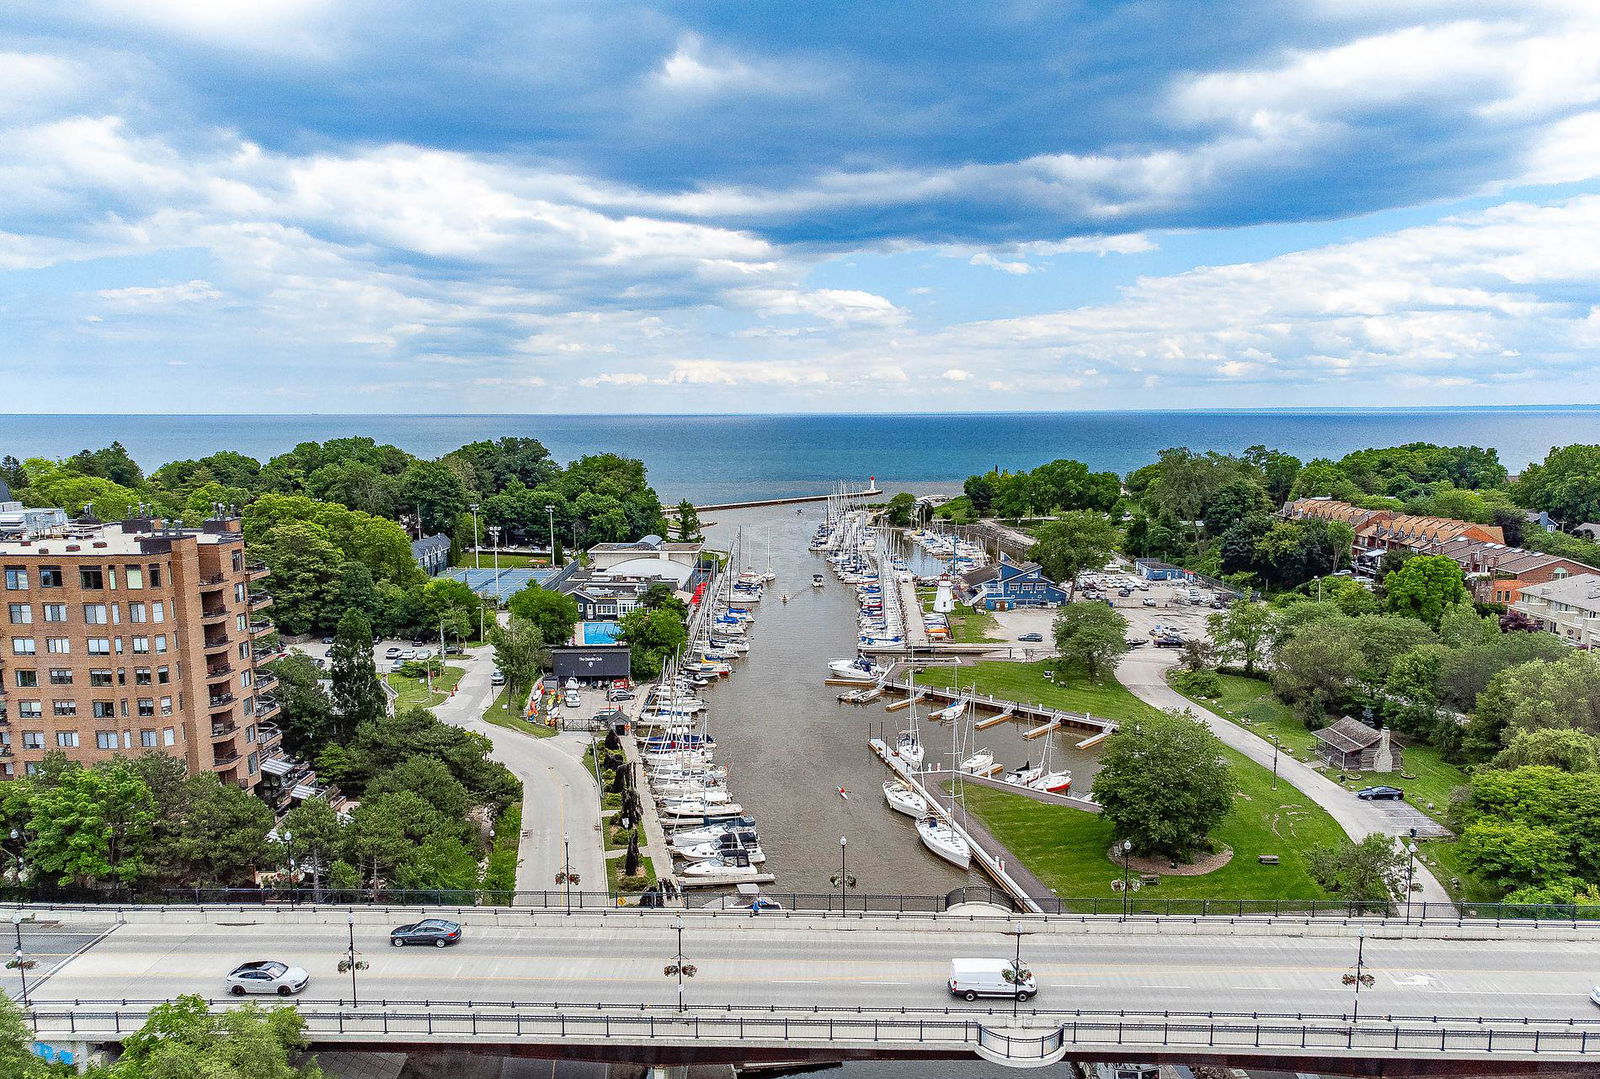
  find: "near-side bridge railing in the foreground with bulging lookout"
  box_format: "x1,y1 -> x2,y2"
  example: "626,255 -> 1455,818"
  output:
27,1002 -> 1600,1063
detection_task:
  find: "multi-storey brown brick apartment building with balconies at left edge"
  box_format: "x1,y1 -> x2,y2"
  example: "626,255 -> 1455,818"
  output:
0,517 -> 278,789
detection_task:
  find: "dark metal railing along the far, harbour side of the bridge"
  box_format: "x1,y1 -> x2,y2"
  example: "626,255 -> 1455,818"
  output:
0,887 -> 1600,924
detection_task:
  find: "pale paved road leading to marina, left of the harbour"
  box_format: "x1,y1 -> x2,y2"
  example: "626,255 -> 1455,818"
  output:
434,648 -> 606,892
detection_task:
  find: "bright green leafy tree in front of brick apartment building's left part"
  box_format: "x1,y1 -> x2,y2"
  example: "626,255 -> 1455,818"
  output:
27,757 -> 155,887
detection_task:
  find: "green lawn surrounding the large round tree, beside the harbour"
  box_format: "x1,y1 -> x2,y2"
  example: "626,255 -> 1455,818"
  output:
966,739 -> 1344,900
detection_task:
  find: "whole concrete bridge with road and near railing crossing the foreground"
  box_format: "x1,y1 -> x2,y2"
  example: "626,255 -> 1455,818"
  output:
5,906 -> 1600,1076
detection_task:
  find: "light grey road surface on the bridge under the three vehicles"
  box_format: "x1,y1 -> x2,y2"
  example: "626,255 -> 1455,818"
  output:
21,914 -> 1600,1020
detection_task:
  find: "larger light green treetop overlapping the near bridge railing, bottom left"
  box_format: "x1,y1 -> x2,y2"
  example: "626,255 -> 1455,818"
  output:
110,996 -> 323,1079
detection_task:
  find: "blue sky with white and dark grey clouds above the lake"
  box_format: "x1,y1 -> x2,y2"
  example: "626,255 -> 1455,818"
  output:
0,0 -> 1600,413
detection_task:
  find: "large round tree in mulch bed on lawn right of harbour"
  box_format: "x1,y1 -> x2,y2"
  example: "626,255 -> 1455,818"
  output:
1094,712 -> 1237,858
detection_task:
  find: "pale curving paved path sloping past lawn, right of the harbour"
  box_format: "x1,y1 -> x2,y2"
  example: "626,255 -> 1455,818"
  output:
1117,648 -> 1451,903
